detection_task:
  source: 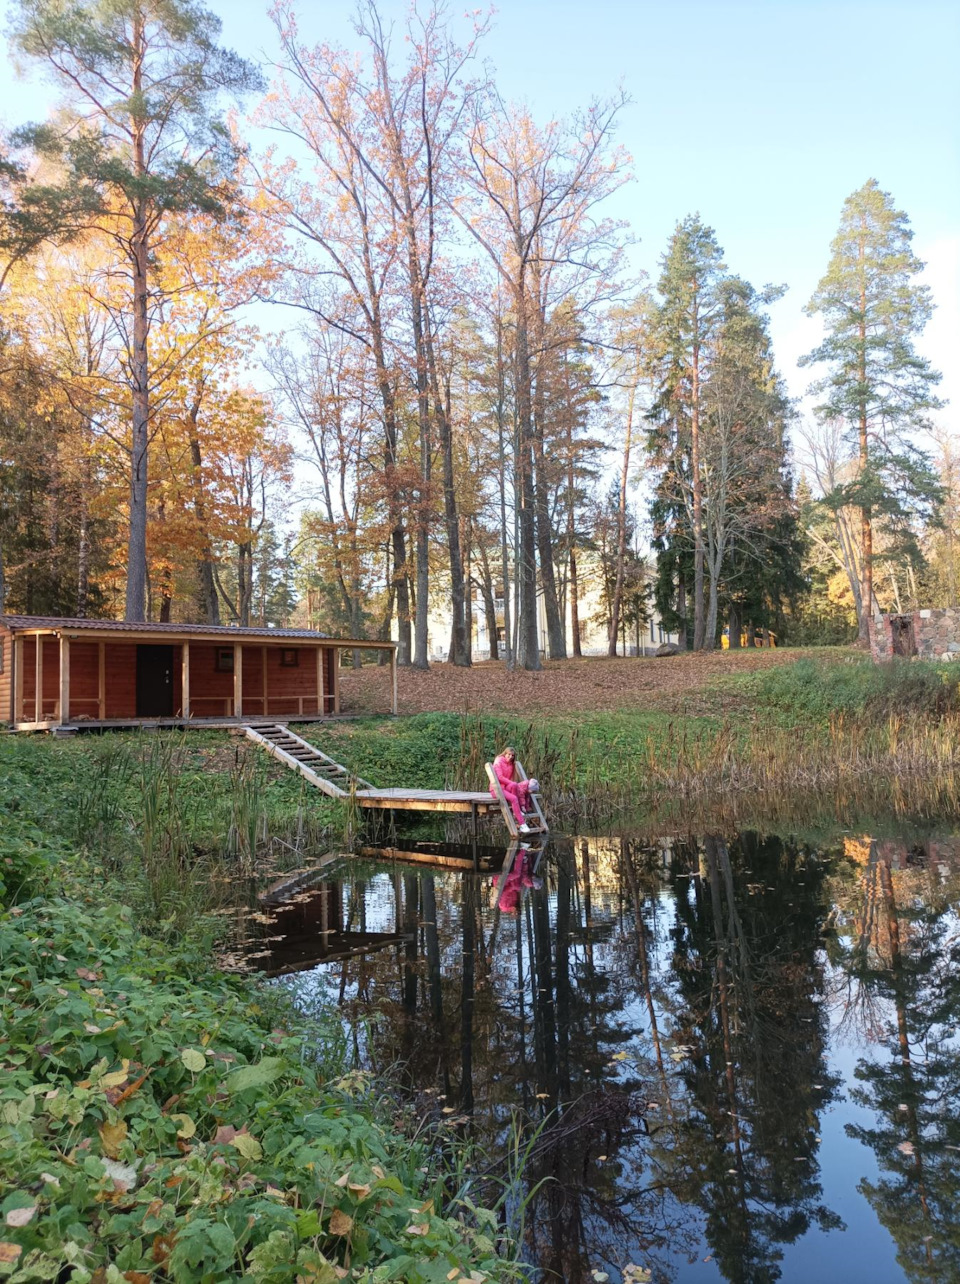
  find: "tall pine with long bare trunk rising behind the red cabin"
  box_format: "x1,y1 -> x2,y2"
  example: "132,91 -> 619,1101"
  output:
13,0 -> 261,620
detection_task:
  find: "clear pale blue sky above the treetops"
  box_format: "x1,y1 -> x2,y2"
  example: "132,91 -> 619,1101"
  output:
0,0 -> 960,426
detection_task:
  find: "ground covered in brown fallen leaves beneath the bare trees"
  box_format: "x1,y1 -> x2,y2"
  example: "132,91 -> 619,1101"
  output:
340,647 -> 860,716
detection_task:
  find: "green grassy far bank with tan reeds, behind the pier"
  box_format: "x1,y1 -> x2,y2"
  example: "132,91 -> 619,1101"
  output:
304,654 -> 960,824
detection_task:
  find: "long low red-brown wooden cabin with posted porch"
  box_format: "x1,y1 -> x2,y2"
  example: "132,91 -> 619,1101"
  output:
0,615 -> 397,731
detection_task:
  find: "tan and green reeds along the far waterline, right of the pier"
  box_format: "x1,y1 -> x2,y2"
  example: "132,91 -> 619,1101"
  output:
449,706 -> 960,824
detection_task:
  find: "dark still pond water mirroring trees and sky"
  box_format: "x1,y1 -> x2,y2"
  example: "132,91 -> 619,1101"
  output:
245,833 -> 960,1284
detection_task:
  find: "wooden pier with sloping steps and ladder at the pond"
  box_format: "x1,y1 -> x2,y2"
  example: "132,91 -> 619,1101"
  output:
243,723 -> 547,838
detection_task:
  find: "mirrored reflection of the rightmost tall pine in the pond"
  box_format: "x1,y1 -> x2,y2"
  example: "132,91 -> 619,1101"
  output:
836,838 -> 960,1284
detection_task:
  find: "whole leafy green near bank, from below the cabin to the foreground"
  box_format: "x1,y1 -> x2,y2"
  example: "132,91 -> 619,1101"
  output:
0,737 -> 521,1284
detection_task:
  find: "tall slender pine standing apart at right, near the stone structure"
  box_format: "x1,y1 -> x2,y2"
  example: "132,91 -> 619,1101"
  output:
801,178 -> 941,642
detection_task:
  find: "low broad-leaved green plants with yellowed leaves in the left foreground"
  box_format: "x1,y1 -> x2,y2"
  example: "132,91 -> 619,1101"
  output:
0,900 -> 502,1284
